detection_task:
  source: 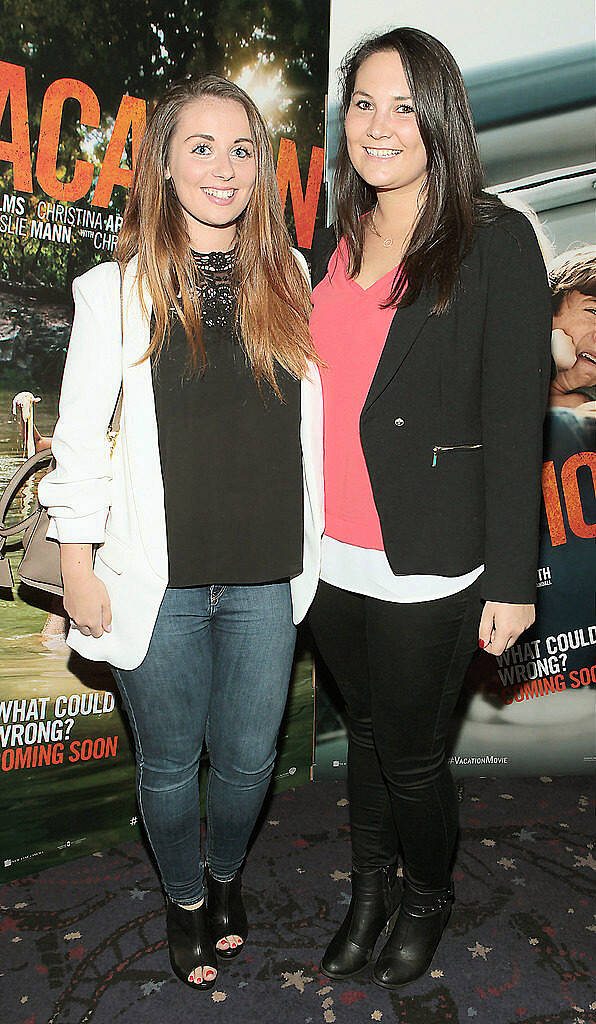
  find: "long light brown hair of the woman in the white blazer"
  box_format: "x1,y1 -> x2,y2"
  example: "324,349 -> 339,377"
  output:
116,75 -> 316,394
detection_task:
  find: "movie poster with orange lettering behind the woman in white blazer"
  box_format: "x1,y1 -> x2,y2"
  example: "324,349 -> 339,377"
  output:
0,0 -> 328,879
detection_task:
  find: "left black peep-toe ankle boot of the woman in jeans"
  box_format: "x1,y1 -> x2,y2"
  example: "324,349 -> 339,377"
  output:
166,897 -> 217,991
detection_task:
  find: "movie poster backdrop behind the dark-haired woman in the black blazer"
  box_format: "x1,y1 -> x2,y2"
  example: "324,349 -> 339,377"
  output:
314,0 -> 596,778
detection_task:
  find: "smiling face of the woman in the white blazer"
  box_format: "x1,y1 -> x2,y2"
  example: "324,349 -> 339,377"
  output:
166,96 -> 256,252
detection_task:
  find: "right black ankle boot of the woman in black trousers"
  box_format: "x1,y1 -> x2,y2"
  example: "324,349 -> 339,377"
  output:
373,879 -> 454,988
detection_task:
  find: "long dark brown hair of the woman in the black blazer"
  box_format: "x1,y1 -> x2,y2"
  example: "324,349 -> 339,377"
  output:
334,28 -> 503,313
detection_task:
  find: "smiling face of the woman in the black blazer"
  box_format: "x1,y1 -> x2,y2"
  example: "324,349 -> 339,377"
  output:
344,50 -> 427,195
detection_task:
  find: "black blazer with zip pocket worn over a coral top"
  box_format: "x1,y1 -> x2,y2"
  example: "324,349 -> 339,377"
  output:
312,207 -> 552,604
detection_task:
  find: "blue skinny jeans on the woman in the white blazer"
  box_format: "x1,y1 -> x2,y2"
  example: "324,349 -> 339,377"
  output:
113,583 -> 296,903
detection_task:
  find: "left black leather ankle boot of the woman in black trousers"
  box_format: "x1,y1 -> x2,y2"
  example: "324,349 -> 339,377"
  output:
321,864 -> 399,979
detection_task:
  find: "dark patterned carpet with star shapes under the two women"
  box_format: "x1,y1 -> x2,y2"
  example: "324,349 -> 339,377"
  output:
0,777 -> 596,1024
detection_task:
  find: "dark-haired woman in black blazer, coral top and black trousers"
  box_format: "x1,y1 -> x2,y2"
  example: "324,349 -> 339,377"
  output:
310,29 -> 551,988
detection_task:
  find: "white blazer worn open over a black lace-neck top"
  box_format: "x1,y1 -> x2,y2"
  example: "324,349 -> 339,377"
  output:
39,253 -> 325,669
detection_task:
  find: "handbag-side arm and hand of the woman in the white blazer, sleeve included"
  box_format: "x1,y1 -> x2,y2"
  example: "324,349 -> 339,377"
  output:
38,264 -> 122,636
